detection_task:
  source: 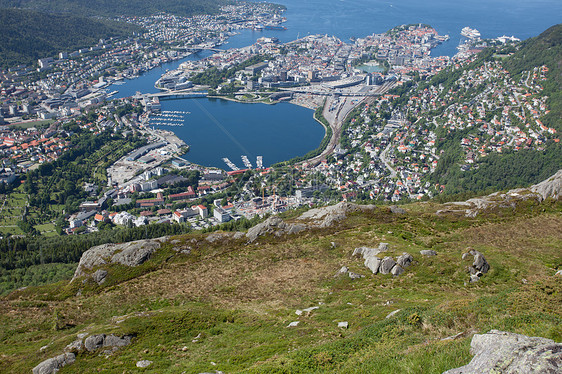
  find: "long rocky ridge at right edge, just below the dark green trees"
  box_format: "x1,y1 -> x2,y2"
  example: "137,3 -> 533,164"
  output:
436,170 -> 562,217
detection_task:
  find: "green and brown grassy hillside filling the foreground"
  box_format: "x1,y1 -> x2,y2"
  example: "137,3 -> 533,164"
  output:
0,200 -> 562,374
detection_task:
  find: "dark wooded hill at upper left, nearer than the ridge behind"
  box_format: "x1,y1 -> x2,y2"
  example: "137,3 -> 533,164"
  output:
0,9 -> 138,68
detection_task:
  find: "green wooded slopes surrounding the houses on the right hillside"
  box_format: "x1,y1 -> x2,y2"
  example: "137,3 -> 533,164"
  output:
426,24 -> 562,194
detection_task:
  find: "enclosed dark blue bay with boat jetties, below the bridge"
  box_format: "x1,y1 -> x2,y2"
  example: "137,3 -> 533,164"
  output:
153,98 -> 324,170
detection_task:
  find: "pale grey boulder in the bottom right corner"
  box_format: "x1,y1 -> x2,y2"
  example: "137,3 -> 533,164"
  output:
444,330 -> 562,374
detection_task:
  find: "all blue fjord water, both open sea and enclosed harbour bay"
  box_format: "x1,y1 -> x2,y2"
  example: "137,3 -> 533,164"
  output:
109,0 -> 562,168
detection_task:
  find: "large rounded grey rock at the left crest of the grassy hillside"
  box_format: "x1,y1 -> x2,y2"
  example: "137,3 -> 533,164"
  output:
72,238 -> 167,284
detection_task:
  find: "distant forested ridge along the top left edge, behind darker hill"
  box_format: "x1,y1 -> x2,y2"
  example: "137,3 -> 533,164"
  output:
0,0 -> 227,17
